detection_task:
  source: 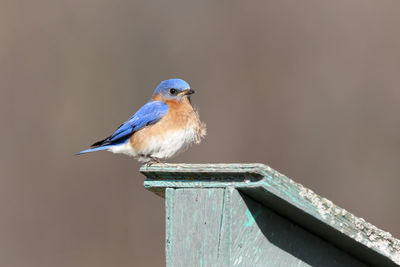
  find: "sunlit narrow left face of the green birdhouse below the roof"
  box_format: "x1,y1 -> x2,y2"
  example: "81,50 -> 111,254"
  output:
166,188 -> 231,267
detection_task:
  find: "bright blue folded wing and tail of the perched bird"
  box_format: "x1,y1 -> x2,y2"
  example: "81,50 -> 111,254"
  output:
78,101 -> 168,154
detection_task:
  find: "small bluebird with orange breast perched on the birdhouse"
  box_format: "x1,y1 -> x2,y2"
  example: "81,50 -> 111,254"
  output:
77,78 -> 207,163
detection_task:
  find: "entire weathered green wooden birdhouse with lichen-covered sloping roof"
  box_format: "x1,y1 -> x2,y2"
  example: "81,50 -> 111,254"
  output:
141,164 -> 400,266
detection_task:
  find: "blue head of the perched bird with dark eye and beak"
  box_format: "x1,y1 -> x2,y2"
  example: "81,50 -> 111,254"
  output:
153,79 -> 194,100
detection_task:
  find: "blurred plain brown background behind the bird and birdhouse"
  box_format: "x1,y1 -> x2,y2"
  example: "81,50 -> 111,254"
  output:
0,0 -> 400,267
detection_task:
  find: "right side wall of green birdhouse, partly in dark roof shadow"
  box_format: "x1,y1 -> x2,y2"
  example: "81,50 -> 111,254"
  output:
231,190 -> 367,267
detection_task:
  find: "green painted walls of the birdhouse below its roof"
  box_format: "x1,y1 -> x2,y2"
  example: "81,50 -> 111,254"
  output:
166,187 -> 366,267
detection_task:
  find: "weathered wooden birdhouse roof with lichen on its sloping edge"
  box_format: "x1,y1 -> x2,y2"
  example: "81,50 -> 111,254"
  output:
140,163 -> 400,266
